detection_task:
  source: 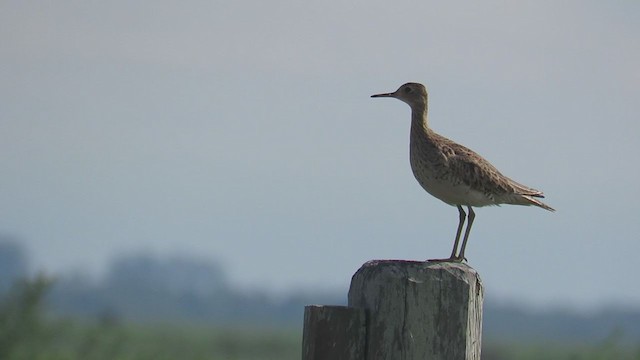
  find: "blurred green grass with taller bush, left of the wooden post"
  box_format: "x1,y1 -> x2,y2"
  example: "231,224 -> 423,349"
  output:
0,277 -> 302,360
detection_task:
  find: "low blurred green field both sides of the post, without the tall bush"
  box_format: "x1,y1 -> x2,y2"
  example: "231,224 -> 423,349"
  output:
1,320 -> 640,360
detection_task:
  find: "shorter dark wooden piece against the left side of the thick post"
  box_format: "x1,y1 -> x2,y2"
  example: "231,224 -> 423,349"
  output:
302,305 -> 366,360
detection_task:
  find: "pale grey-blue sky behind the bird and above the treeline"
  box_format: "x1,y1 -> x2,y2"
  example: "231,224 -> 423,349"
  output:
0,0 -> 640,309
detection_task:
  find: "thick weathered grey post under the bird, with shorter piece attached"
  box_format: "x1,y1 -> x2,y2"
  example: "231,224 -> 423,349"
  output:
303,260 -> 483,360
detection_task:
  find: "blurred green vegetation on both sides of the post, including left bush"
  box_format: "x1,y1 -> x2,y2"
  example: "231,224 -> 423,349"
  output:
0,279 -> 640,360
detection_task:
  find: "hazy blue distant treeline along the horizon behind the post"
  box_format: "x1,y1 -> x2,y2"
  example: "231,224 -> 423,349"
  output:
0,239 -> 640,343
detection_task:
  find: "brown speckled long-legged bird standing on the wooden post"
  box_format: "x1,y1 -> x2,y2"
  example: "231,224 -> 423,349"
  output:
371,82 -> 555,262
